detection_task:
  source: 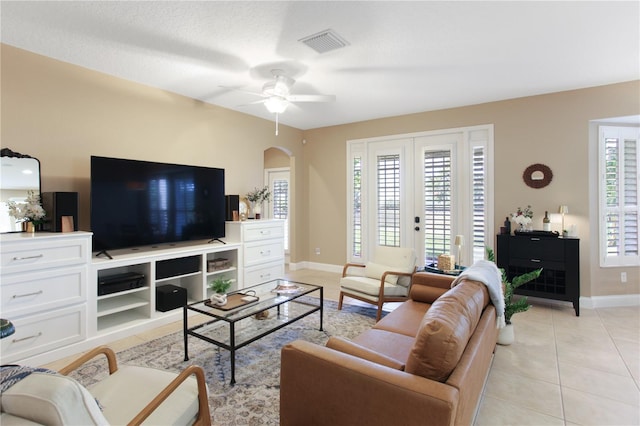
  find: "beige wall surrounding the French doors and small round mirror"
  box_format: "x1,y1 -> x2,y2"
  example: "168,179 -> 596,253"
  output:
303,81 -> 640,296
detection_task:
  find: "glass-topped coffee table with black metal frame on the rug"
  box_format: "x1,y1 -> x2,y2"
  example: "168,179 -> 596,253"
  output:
183,279 -> 324,385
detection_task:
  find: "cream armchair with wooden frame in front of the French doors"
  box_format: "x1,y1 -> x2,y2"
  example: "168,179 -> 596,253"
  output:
338,246 -> 416,321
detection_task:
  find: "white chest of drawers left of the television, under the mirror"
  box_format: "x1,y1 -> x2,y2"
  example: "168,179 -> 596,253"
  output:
0,232 -> 91,364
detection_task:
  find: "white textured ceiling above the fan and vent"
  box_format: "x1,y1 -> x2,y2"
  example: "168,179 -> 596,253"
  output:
0,0 -> 640,129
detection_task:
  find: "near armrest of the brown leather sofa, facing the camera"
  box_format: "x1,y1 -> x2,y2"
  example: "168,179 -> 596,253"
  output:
280,340 -> 458,426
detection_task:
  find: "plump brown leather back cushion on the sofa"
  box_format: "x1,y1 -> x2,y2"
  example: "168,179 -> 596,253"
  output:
406,280 -> 489,382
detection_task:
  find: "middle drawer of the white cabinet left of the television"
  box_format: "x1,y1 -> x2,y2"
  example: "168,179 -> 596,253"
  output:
0,266 -> 87,318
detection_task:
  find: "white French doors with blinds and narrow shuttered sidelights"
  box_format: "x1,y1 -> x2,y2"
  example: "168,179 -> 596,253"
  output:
348,126 -> 493,266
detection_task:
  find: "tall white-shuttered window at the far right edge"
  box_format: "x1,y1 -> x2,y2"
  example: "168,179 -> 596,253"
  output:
599,126 -> 640,266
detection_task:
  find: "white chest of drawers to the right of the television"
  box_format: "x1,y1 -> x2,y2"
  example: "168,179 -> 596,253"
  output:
225,219 -> 284,288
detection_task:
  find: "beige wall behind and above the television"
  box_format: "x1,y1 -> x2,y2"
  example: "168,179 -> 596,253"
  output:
1,45 -> 302,258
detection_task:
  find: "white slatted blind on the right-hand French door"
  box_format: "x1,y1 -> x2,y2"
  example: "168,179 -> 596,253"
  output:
424,150 -> 452,264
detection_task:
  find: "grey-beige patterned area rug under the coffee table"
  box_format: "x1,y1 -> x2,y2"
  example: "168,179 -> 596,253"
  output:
72,301 -> 376,425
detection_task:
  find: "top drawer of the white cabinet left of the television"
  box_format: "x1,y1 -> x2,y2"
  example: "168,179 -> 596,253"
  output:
0,239 -> 89,275
